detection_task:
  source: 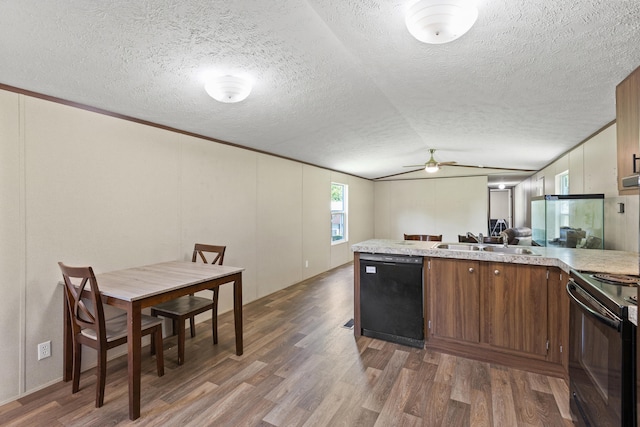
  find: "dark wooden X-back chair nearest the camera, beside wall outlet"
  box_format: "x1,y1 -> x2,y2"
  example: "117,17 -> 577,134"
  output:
58,262 -> 164,408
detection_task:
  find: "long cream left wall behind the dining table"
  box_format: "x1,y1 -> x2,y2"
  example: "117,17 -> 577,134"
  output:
0,91 -> 373,403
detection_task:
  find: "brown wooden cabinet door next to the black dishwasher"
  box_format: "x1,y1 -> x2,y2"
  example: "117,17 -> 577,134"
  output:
429,258 -> 480,343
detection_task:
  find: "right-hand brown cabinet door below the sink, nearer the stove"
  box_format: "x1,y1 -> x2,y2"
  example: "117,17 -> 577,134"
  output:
482,263 -> 548,357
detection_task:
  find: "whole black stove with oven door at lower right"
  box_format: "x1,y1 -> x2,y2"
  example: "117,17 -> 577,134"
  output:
566,270 -> 639,427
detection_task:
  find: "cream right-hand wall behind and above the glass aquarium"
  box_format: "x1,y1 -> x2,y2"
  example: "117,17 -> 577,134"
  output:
515,124 -> 640,252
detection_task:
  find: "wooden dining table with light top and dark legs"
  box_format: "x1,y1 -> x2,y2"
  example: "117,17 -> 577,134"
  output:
63,261 -> 244,420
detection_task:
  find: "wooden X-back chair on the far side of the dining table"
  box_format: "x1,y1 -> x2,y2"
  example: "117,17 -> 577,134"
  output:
151,243 -> 227,365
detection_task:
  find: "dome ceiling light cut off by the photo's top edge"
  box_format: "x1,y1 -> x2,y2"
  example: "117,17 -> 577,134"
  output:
405,0 -> 478,44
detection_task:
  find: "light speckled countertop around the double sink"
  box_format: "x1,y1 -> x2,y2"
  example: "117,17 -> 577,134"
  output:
351,239 -> 638,275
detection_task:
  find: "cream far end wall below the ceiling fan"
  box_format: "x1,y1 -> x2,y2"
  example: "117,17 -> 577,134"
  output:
375,176 -> 489,242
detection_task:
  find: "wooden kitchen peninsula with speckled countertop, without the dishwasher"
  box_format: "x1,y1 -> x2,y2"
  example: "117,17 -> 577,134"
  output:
352,239 -> 638,378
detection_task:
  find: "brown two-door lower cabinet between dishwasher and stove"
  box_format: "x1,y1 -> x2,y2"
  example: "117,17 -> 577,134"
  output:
426,258 -> 569,377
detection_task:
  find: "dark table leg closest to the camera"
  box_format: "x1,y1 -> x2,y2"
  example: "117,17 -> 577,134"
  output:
127,302 -> 142,420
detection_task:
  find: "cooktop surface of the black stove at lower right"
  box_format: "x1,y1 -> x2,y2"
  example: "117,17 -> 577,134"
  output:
571,270 -> 640,319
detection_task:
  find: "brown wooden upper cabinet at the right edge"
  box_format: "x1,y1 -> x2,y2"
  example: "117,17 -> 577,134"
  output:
616,68 -> 640,194
